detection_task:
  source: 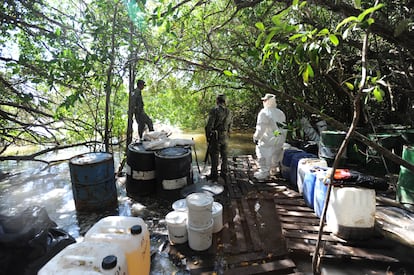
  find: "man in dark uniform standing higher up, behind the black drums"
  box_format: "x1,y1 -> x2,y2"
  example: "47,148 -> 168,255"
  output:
132,79 -> 154,140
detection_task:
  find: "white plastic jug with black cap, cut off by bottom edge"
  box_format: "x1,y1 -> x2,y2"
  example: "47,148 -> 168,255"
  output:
37,242 -> 127,275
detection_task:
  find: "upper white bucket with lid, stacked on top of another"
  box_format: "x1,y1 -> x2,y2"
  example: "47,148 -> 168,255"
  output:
186,193 -> 214,228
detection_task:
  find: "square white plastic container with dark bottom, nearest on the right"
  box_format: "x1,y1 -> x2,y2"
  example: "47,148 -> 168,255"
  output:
326,187 -> 376,239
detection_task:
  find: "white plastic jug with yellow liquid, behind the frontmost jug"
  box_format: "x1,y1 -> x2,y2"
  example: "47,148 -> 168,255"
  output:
84,216 -> 150,274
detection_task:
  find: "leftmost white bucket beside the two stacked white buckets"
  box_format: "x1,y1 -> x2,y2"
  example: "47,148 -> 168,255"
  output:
165,211 -> 188,244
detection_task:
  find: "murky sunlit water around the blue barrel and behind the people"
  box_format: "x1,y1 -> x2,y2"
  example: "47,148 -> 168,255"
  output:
0,132 -> 254,274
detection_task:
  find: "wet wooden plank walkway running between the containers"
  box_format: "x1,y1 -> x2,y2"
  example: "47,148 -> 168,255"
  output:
170,156 -> 414,275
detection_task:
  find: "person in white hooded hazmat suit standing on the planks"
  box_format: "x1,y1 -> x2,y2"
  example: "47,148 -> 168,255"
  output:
253,94 -> 286,180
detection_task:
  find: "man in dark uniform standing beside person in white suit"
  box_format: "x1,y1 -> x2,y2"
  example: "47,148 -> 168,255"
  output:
205,94 -> 232,181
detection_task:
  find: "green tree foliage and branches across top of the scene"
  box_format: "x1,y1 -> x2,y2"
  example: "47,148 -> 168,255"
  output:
0,0 -> 414,161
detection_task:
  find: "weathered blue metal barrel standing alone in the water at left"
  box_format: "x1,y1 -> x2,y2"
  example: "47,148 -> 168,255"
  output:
69,153 -> 118,211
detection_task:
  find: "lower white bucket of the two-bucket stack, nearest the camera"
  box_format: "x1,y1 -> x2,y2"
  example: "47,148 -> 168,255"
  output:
187,219 -> 214,251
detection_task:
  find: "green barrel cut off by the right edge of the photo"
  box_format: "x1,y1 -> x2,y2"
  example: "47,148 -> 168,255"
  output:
397,146 -> 414,205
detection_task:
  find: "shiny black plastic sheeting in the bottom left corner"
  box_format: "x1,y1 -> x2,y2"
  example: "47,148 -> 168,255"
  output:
0,206 -> 76,275
